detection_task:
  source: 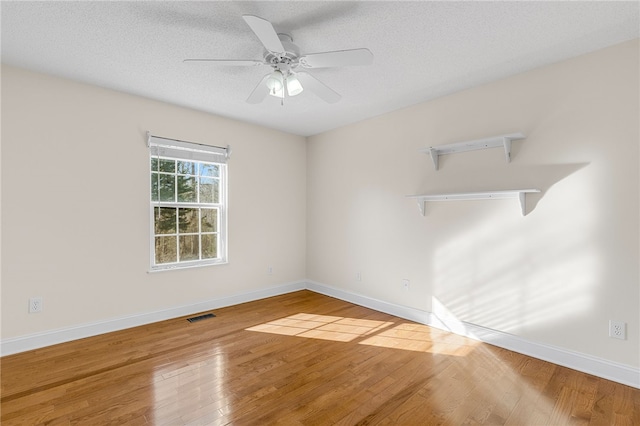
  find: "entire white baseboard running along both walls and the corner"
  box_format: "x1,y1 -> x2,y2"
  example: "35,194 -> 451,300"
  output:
0,280 -> 640,389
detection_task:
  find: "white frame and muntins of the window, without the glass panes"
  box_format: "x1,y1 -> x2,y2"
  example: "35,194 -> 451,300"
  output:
147,134 -> 230,272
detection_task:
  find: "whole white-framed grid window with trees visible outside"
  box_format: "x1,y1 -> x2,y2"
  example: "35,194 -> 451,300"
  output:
149,136 -> 228,270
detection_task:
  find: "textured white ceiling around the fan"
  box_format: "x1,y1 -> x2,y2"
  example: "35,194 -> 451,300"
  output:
0,1 -> 640,136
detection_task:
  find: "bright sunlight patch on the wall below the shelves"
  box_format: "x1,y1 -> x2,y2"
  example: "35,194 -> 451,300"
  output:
432,179 -> 603,332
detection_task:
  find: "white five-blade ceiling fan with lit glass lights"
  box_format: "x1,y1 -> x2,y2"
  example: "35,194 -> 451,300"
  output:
183,15 -> 373,104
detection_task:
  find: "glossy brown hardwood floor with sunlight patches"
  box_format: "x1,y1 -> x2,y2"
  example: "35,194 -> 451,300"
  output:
0,291 -> 640,426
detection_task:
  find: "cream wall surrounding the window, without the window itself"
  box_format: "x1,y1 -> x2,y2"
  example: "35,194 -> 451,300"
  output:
2,66 -> 306,339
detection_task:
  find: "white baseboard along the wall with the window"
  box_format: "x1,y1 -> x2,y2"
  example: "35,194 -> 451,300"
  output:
0,281 -> 306,356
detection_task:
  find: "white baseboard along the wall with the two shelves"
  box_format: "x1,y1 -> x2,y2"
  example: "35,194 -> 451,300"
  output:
307,280 -> 640,389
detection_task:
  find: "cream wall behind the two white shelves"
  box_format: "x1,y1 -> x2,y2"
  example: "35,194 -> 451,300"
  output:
307,40 -> 640,367
